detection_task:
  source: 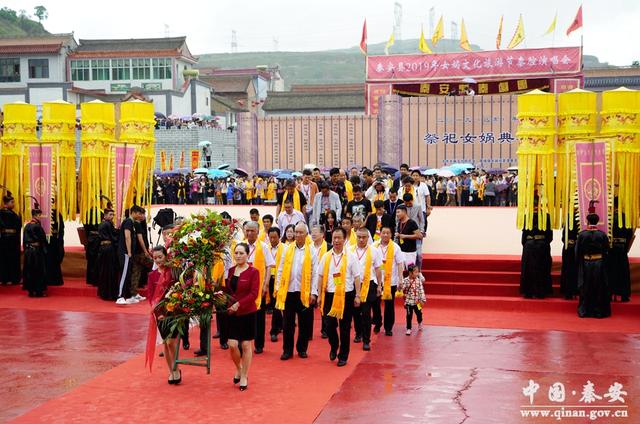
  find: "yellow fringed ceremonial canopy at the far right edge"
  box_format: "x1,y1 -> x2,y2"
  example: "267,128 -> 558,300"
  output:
600,87 -> 640,228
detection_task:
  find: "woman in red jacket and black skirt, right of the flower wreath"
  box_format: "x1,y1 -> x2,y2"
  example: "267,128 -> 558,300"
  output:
225,243 -> 260,391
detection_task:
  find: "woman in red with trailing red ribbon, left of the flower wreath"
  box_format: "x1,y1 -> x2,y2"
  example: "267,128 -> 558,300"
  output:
145,246 -> 182,384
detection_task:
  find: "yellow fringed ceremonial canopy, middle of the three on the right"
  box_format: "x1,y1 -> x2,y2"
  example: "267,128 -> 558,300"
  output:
555,88 -> 597,235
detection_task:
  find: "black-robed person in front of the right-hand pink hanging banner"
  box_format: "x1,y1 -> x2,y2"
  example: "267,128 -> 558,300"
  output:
576,207 -> 611,318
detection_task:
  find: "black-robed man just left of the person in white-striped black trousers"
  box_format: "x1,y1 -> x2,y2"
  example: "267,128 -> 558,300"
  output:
96,209 -> 120,300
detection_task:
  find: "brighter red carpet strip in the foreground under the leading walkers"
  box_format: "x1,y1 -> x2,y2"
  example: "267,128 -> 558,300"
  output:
7,311 -> 364,423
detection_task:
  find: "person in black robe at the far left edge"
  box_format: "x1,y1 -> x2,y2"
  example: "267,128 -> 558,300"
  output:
0,192 -> 22,285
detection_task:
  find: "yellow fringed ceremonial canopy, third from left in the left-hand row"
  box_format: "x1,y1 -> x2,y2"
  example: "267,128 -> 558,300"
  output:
80,100 -> 115,224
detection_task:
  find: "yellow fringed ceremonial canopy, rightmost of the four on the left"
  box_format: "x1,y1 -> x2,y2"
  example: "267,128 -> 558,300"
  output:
119,100 -> 155,212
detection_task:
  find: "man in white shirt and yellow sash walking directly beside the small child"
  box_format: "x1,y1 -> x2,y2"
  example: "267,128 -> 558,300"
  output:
374,227 -> 404,336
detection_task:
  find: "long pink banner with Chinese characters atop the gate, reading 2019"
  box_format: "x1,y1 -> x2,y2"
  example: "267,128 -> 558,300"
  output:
366,47 -> 582,82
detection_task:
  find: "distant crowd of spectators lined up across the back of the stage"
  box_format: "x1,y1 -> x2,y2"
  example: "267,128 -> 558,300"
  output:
153,164 -> 518,206
